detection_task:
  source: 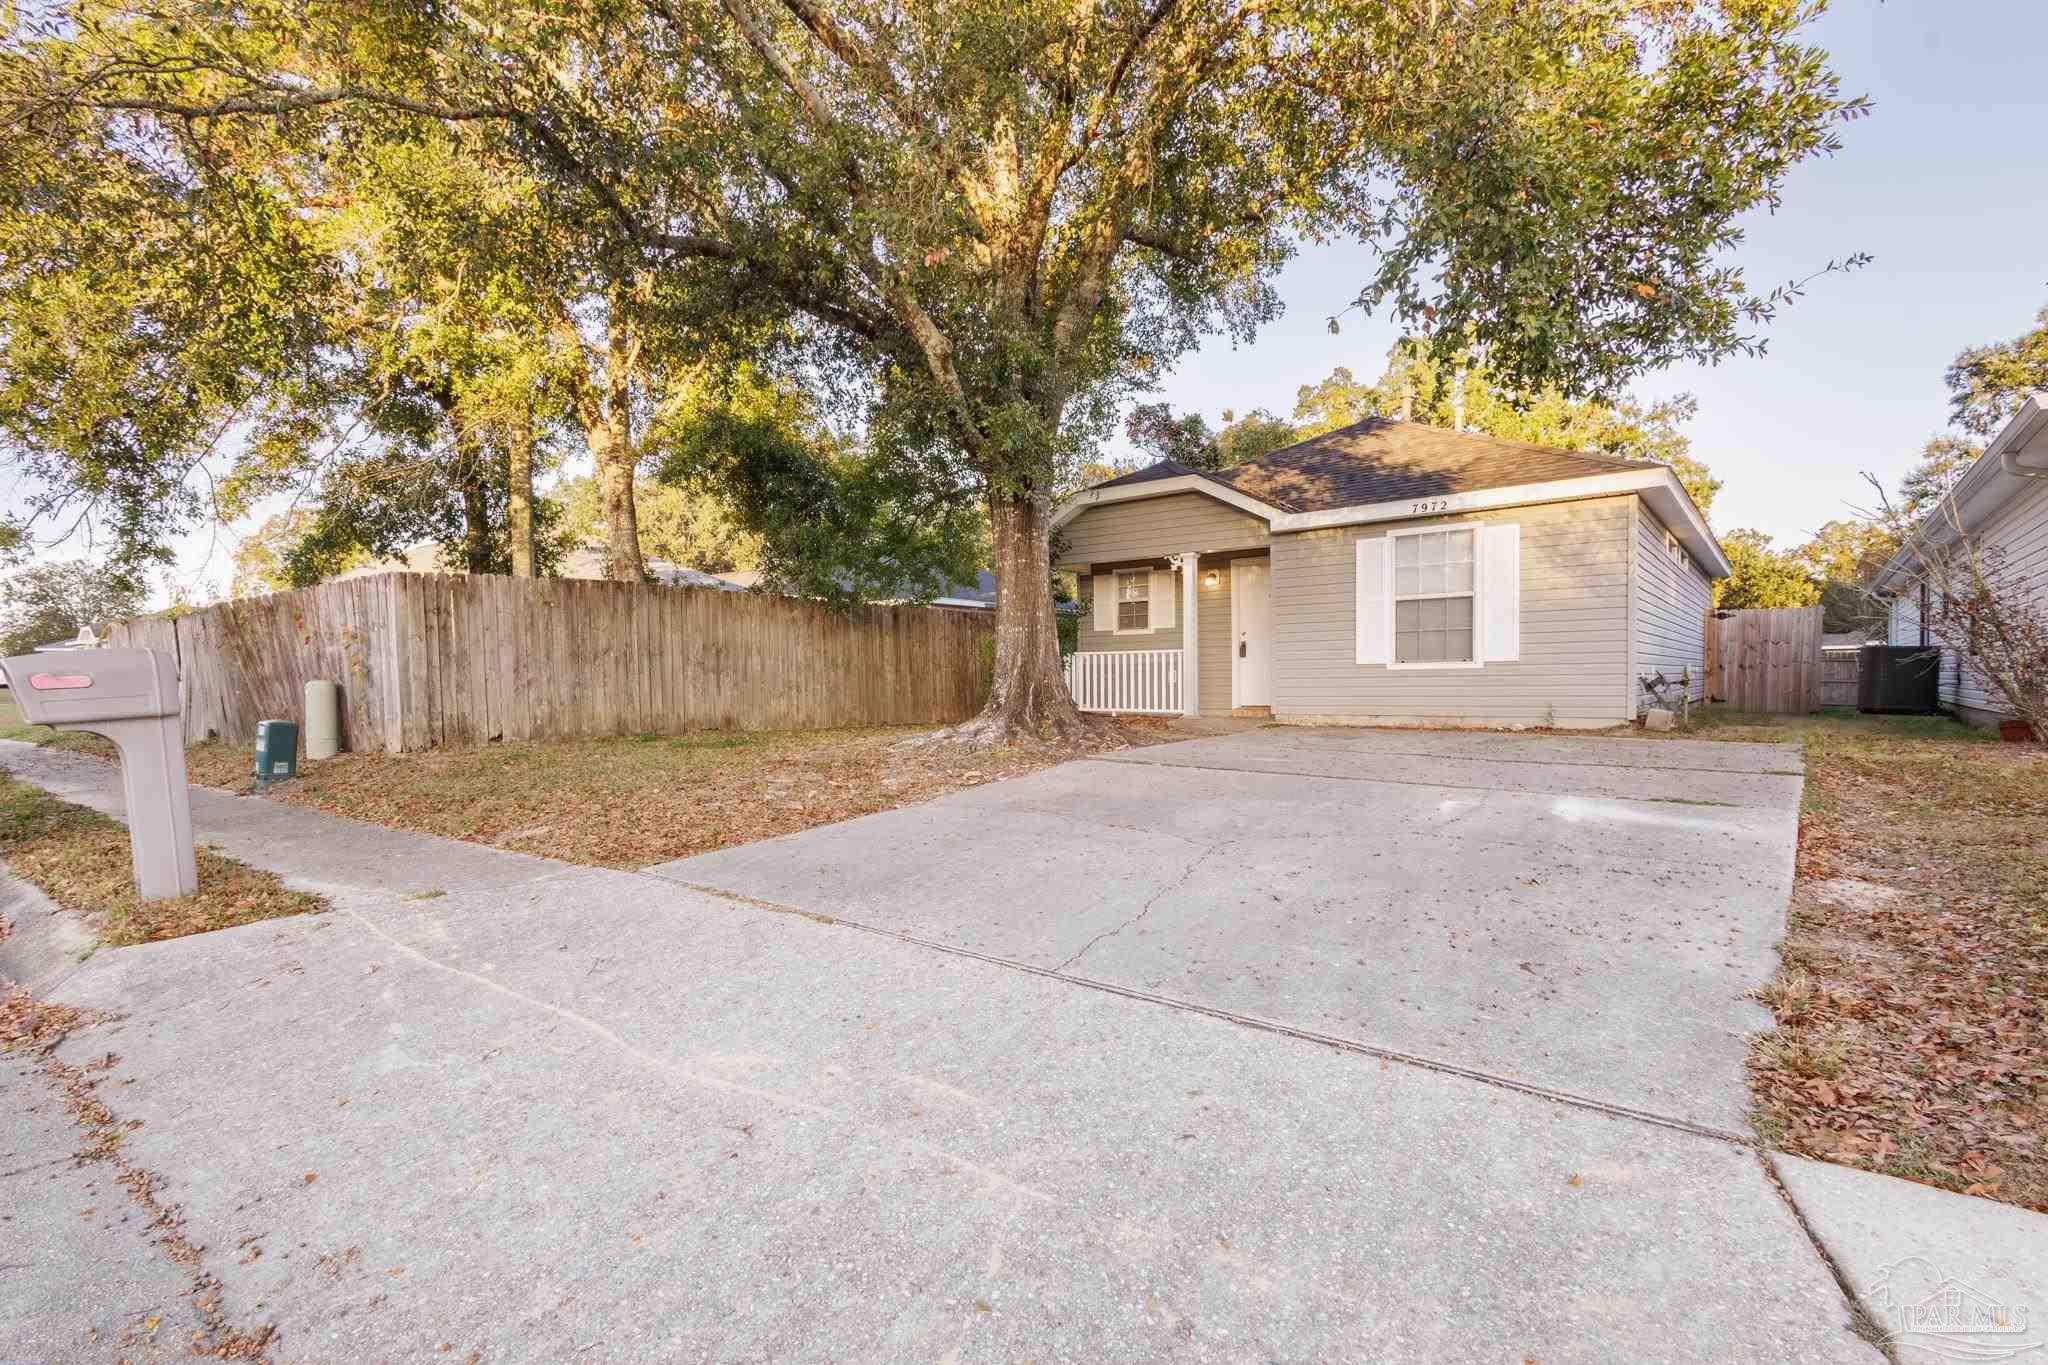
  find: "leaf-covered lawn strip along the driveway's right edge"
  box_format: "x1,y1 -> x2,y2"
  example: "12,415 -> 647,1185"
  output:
1654,710 -> 2048,1212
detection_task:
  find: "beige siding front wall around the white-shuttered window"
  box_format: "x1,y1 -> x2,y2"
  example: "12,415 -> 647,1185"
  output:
1272,495 -> 1634,726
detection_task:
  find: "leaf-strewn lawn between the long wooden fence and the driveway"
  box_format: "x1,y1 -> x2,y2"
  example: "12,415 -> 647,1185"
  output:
186,722 -> 1167,868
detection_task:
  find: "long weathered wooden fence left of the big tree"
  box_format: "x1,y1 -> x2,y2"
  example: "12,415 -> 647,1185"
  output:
109,573 -> 993,753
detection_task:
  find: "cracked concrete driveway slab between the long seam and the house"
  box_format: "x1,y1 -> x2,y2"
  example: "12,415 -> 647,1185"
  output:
653,729 -> 1800,1134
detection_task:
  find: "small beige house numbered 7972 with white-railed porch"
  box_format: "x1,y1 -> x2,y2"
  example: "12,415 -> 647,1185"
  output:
1055,420 -> 1729,729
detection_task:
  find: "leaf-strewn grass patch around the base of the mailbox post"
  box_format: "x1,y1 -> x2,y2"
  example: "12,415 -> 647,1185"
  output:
0,778 -> 328,948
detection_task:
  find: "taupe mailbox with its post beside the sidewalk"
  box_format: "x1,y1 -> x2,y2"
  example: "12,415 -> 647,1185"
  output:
0,649 -> 199,900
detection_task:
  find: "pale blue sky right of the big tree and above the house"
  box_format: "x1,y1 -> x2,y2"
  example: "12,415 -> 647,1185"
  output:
1122,0 -> 2048,546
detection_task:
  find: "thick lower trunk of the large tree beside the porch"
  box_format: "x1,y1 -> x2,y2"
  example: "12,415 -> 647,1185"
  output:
934,493 -> 1106,745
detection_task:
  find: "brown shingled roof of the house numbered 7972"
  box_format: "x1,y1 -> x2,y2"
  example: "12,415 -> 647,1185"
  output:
1096,417 -> 1661,512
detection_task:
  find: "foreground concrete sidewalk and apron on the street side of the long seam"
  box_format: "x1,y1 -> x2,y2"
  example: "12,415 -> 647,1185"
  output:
0,745 -> 2015,1363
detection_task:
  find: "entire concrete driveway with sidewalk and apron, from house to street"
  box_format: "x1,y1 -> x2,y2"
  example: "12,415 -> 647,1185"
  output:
0,731 -> 1880,1365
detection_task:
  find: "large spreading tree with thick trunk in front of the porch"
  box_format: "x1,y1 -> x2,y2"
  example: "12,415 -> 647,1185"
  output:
12,0 -> 1858,741
